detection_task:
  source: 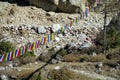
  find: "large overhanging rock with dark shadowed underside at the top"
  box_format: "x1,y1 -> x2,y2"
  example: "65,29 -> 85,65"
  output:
29,0 -> 87,13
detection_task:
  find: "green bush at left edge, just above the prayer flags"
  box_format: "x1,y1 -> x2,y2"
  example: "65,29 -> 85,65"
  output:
0,41 -> 15,54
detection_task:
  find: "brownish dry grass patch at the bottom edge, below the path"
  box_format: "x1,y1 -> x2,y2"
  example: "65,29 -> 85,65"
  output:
50,67 -> 98,80
